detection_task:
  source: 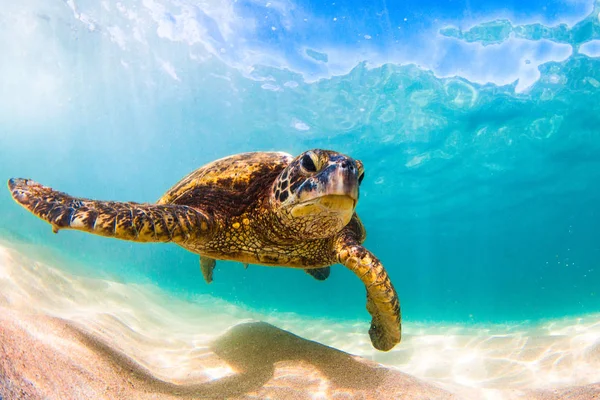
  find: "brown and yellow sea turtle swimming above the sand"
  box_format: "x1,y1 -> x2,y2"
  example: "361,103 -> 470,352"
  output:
8,149 -> 401,351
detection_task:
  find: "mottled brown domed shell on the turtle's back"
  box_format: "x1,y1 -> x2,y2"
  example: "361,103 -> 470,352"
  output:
158,152 -> 294,215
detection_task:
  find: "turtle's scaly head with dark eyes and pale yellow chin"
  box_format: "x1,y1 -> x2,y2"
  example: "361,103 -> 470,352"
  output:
271,149 -> 364,239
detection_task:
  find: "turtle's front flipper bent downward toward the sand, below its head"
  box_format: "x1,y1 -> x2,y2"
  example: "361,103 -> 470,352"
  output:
336,239 -> 402,351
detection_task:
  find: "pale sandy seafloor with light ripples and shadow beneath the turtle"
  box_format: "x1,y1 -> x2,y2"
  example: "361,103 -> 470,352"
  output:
0,242 -> 600,399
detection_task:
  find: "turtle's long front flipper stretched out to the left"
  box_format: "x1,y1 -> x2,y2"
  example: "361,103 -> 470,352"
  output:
8,179 -> 212,243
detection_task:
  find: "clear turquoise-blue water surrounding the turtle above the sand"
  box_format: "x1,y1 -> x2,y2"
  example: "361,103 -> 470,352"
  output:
0,0 -> 600,323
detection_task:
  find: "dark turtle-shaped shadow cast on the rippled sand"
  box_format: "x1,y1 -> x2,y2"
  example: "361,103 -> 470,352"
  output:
71,322 -> 443,399
